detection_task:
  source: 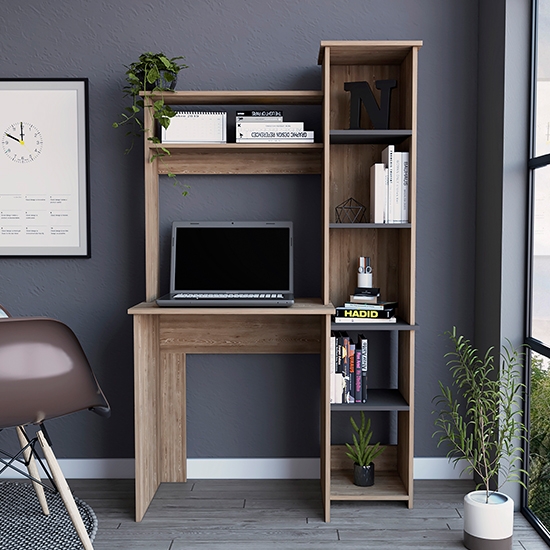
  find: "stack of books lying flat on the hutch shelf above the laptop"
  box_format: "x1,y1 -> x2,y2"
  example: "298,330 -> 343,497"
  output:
235,110 -> 314,143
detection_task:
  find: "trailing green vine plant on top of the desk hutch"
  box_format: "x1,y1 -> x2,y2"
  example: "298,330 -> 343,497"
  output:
113,52 -> 187,154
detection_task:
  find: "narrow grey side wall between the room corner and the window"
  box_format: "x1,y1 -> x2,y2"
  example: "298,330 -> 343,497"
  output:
475,0 -> 531,507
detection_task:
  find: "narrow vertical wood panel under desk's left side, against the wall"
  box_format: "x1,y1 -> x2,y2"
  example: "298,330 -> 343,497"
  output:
159,352 -> 187,482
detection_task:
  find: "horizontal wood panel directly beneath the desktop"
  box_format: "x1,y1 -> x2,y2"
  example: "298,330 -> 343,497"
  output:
160,314 -> 322,354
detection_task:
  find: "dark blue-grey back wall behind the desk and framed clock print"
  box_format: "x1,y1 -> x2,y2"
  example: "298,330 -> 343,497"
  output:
0,0 -> 484,458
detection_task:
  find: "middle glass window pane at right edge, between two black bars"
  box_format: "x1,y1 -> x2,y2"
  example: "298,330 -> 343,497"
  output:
531,166 -> 550,346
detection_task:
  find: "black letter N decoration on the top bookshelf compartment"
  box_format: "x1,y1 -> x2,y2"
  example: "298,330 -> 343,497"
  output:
344,80 -> 397,130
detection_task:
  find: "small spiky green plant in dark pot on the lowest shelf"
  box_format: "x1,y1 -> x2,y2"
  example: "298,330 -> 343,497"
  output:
346,411 -> 384,487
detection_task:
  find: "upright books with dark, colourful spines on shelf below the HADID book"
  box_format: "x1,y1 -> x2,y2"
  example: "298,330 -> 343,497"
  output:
330,331 -> 369,403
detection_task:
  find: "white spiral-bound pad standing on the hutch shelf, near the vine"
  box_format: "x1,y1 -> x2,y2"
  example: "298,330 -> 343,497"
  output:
161,111 -> 227,143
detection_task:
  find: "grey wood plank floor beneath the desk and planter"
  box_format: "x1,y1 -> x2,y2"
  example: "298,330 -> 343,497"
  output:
62,480 -> 548,550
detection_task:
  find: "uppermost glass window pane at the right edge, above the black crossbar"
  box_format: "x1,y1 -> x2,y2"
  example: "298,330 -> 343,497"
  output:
535,0 -> 550,157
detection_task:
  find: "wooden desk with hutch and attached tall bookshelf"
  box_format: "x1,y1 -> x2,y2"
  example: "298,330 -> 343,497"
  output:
128,41 -> 421,521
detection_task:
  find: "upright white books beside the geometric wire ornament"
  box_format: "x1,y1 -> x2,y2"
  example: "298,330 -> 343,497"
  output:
370,145 -> 409,223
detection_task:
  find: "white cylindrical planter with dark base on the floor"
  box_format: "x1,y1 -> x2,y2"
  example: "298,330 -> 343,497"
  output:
464,491 -> 514,550
